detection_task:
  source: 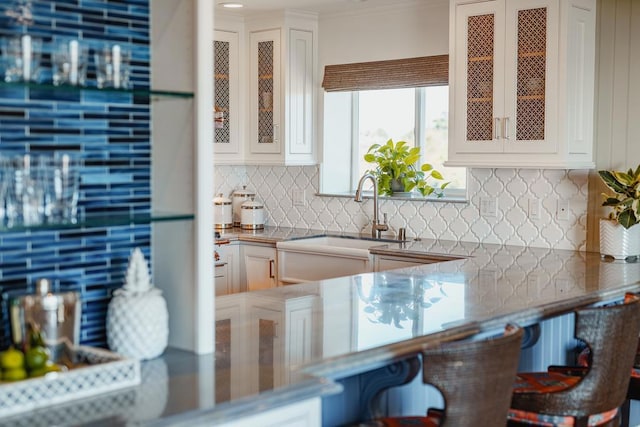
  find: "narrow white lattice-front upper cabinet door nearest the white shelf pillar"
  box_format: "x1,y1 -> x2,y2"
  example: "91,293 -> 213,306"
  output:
212,30 -> 243,164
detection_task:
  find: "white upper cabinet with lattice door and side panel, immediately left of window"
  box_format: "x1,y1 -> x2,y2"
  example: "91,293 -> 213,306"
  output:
245,11 -> 317,165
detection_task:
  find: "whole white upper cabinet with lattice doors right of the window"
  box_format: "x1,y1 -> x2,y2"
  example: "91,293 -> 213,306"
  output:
447,0 -> 595,169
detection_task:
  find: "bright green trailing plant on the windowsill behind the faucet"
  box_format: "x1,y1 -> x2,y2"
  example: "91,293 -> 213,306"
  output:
364,139 -> 449,197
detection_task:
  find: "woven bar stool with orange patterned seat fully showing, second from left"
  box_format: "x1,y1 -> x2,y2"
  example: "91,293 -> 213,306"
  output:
508,295 -> 640,427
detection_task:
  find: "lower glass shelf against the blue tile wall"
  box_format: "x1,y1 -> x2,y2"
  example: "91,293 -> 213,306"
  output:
0,212 -> 195,234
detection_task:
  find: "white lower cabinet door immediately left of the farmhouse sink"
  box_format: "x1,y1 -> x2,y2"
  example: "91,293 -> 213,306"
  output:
240,242 -> 278,291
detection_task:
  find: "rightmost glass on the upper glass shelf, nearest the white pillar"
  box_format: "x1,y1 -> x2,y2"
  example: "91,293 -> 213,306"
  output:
94,44 -> 131,89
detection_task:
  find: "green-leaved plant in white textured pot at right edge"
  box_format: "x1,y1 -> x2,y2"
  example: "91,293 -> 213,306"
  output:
598,166 -> 640,259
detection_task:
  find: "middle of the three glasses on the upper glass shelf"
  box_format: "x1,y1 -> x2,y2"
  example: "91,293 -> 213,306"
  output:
51,40 -> 89,86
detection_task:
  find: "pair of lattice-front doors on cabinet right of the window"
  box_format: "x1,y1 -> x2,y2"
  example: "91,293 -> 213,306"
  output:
452,0 -> 559,159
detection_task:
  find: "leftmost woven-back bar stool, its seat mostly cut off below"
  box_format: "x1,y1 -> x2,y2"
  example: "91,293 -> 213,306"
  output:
359,325 -> 524,427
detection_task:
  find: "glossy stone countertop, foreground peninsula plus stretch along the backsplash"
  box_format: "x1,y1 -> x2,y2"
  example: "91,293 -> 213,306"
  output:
6,228 -> 640,426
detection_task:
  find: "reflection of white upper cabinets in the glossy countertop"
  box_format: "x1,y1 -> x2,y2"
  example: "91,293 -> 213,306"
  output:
215,293 -> 322,401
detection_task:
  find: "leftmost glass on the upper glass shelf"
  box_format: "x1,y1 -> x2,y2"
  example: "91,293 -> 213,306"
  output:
0,34 -> 42,82
